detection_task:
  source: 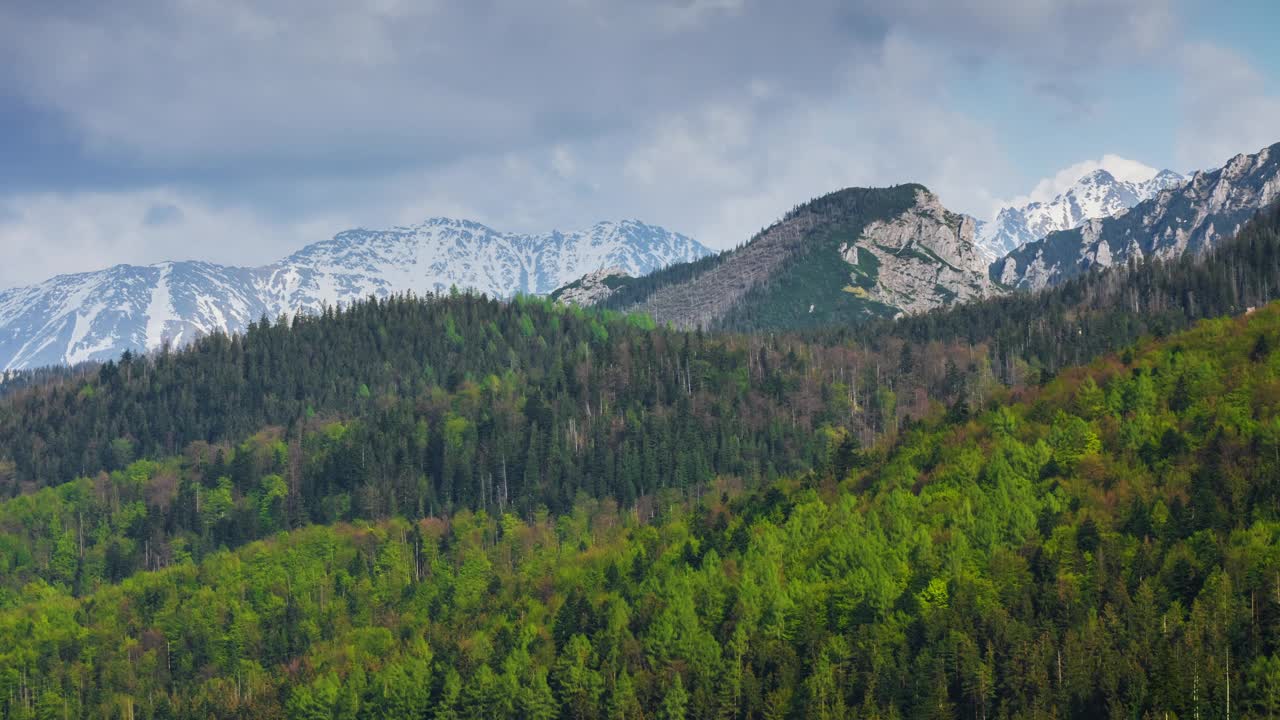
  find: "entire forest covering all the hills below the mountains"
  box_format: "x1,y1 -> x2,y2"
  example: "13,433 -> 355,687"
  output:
0,210 -> 1280,719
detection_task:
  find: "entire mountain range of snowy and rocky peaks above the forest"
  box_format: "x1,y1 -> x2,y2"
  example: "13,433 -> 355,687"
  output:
10,146 -> 1280,369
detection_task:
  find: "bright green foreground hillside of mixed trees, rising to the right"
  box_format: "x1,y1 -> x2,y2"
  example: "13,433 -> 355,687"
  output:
0,295 -> 1280,719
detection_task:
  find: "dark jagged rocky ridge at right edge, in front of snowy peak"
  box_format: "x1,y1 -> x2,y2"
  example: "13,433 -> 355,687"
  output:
991,143 -> 1280,290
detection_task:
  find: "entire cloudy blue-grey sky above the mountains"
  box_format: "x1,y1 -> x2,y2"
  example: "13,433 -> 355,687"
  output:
0,0 -> 1280,287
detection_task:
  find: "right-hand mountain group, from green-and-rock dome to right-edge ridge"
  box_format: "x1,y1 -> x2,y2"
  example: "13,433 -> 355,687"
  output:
573,145 -> 1280,331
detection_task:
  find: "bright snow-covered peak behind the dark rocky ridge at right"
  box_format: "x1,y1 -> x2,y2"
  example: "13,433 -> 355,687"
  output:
978,169 -> 1187,261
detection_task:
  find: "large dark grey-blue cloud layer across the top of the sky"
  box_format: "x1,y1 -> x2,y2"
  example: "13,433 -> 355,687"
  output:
0,0 -> 1171,176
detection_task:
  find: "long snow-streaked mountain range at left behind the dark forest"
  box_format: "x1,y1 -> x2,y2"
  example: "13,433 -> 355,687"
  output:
0,218 -> 712,369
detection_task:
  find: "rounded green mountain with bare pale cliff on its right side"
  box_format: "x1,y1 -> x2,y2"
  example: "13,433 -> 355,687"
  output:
608,184 -> 997,329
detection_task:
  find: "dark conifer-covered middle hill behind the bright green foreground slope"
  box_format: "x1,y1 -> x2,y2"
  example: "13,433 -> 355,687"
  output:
0,288 -> 1018,597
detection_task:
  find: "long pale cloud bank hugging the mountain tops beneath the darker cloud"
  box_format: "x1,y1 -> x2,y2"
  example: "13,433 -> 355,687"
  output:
0,28 -> 1010,287
